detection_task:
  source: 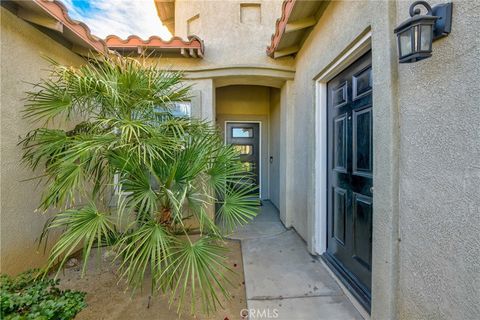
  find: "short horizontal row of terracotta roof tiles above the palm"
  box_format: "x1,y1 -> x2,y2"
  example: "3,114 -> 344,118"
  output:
105,35 -> 204,54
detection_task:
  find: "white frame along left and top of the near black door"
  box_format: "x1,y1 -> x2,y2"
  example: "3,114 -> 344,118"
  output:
313,29 -> 373,255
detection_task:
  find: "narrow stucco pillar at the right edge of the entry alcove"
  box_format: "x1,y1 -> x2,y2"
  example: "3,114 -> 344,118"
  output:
279,80 -> 295,228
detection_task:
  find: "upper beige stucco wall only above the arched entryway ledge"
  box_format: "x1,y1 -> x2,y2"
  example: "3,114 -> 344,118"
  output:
167,0 -> 293,69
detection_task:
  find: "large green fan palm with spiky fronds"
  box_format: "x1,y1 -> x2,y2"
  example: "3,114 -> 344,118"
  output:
21,57 -> 258,313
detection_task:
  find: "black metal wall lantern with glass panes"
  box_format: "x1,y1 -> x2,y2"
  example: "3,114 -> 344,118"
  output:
394,1 -> 452,63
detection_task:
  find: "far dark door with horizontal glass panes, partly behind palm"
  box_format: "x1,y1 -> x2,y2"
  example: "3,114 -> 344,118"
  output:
226,122 -> 260,187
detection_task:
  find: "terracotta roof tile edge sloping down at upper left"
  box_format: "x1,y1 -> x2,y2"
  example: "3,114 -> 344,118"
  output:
33,0 -> 108,53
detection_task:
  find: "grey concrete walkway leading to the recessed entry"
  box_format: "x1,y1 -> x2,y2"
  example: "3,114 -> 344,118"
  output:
232,201 -> 363,320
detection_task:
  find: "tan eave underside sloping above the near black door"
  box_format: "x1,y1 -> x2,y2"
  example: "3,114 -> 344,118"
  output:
267,0 -> 330,59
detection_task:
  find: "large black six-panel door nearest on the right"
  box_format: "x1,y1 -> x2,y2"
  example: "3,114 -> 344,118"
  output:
325,52 -> 373,310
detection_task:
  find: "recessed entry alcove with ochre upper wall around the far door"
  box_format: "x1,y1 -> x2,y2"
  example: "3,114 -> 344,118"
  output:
215,84 -> 281,208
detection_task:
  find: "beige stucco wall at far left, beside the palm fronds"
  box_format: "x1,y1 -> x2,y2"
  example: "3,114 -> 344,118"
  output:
0,7 -> 83,273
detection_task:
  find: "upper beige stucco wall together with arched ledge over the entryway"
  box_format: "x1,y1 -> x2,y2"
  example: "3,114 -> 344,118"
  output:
152,0 -> 294,94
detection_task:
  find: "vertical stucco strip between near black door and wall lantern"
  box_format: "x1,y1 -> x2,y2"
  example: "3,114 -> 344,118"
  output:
371,1 -> 400,320
